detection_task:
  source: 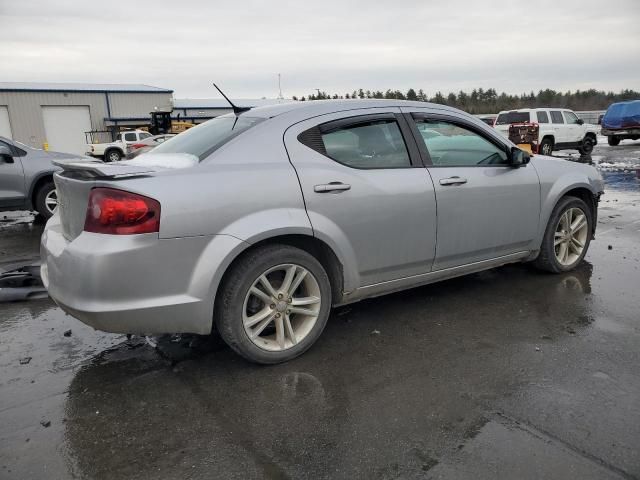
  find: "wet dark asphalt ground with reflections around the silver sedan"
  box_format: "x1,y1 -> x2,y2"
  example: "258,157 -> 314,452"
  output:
0,142 -> 640,479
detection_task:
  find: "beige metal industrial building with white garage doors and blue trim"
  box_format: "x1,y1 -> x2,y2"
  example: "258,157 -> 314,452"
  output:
0,82 -> 173,154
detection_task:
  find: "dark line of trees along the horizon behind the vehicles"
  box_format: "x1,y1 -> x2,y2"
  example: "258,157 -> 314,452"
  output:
292,88 -> 640,114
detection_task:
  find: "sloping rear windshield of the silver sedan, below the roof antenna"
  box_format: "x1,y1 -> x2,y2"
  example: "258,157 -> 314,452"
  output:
153,115 -> 264,160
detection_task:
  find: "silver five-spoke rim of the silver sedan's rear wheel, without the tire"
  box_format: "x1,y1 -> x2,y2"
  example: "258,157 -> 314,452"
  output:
242,263 -> 322,351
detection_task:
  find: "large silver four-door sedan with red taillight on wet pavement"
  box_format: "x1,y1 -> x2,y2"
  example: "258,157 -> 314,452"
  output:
41,100 -> 603,364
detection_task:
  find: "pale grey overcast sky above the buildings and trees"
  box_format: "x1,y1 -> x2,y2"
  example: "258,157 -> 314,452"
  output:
0,0 -> 640,98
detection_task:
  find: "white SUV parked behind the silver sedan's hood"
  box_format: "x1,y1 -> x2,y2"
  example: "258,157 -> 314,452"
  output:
494,108 -> 598,155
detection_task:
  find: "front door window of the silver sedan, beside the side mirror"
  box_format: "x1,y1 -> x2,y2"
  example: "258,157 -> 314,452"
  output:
416,120 -> 507,167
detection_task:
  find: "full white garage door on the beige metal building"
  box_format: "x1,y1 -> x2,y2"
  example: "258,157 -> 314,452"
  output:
42,106 -> 91,155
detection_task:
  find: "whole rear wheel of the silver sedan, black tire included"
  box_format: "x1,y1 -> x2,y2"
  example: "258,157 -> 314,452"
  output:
214,245 -> 331,364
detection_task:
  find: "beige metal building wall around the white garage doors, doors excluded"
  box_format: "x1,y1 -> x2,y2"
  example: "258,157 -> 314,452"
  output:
0,91 -> 172,148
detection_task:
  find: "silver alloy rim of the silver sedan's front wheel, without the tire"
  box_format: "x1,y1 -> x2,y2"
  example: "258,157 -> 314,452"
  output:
553,207 -> 589,267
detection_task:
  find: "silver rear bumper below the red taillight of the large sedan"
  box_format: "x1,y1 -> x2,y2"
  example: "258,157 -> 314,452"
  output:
41,215 -> 242,334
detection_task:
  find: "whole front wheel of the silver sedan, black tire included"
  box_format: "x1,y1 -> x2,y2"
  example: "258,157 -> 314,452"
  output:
534,196 -> 593,273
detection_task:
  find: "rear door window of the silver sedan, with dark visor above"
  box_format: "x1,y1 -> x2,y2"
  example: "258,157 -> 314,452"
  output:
321,119 -> 411,169
